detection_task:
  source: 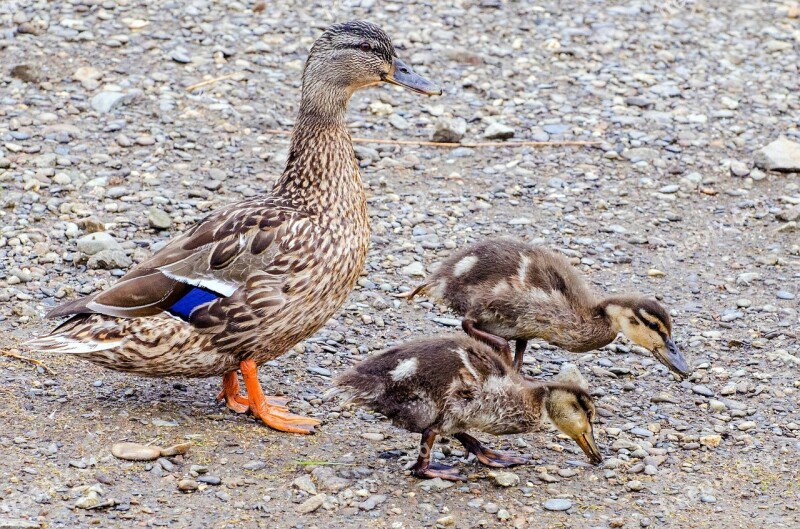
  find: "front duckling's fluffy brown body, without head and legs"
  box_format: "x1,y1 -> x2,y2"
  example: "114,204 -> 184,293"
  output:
332,335 -> 536,433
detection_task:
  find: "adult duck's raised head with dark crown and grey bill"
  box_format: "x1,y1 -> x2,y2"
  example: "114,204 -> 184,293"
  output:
303,20 -> 442,97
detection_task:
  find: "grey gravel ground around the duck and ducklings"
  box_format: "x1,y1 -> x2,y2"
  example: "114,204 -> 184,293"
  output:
0,0 -> 800,529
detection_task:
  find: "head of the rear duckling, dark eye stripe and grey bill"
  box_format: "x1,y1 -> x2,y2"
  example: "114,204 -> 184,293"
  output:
605,296 -> 692,378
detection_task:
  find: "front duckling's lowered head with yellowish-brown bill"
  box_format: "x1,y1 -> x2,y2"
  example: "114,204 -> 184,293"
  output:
543,384 -> 603,465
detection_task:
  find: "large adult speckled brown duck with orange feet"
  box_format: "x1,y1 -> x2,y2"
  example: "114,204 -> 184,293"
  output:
30,21 -> 441,433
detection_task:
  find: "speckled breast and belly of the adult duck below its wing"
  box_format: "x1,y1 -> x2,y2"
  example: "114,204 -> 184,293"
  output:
68,206 -> 369,377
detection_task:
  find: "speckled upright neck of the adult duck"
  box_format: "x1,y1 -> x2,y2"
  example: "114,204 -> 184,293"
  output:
273,83 -> 364,214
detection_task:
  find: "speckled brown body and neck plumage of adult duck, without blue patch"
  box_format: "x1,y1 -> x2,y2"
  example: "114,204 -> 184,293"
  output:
32,123 -> 369,377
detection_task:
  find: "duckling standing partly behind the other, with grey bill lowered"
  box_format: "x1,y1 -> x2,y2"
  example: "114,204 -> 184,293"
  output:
398,238 -> 691,377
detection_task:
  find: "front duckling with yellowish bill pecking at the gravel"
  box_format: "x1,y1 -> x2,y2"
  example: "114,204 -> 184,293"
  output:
328,335 -> 602,481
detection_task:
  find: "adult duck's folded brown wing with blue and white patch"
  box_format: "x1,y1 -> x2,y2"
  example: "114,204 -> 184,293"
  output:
48,198 -> 310,318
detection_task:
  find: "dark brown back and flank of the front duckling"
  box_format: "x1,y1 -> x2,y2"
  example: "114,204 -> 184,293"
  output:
335,335 -> 511,432
